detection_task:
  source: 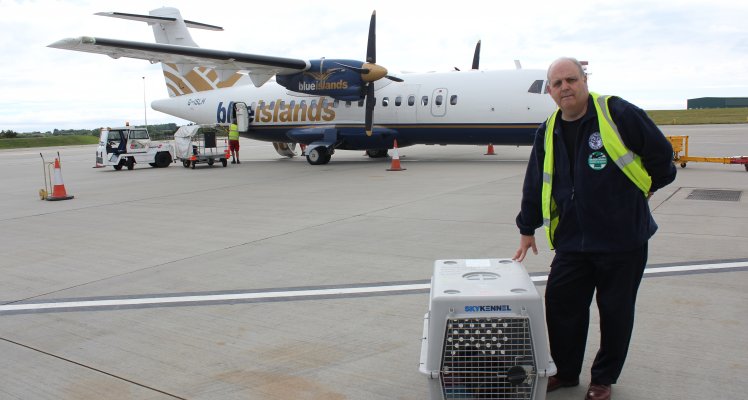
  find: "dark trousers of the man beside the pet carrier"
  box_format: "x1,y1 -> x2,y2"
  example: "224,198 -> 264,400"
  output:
545,243 -> 647,385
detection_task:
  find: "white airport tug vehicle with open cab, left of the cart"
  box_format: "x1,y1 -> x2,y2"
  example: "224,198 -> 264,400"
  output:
94,126 -> 174,171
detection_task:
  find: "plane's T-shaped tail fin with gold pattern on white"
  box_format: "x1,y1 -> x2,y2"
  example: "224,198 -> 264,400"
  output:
96,7 -> 245,97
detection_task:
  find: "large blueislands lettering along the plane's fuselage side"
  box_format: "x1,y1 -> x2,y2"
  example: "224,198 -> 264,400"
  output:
216,98 -> 335,123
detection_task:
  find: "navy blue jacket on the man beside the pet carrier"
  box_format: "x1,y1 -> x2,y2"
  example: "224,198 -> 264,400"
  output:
517,96 -> 676,253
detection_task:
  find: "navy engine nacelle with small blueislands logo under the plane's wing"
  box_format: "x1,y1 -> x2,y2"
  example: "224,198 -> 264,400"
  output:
275,59 -> 365,101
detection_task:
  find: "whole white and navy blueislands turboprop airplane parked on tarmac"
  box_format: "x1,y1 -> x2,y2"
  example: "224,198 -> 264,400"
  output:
49,8 -> 555,165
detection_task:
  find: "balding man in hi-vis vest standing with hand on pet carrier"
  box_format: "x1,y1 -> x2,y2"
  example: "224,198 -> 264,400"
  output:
514,58 -> 675,400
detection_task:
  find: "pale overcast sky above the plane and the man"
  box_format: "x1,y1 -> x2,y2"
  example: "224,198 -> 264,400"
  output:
0,0 -> 748,132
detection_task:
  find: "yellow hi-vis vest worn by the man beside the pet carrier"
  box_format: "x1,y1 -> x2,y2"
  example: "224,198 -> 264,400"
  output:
541,92 -> 652,250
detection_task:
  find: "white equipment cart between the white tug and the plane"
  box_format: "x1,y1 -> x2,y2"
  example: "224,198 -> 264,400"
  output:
174,124 -> 231,169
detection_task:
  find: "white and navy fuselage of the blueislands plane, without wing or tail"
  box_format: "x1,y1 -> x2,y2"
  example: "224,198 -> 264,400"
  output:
152,70 -> 555,150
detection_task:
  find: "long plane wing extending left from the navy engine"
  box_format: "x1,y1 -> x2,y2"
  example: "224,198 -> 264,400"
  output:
48,36 -> 310,87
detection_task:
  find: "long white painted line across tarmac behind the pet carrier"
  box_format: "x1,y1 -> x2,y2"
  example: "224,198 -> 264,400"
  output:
0,261 -> 748,315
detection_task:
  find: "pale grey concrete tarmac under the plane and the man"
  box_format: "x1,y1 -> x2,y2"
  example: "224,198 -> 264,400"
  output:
0,125 -> 748,400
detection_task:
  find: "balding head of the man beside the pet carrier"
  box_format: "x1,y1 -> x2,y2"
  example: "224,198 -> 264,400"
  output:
548,57 -> 590,121
